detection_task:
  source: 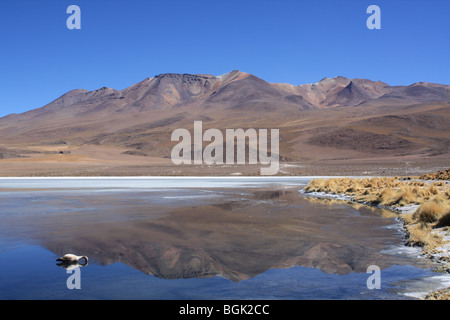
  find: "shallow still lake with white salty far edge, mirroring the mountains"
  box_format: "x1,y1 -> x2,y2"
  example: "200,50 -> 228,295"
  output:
0,177 -> 448,300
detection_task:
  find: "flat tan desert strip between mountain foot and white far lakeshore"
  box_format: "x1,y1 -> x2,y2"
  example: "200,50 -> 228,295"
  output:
0,145 -> 449,177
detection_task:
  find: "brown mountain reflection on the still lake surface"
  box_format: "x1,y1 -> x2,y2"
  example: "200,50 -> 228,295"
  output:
0,187 -> 428,281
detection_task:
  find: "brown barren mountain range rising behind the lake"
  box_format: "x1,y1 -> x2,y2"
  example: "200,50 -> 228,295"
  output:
0,70 -> 450,175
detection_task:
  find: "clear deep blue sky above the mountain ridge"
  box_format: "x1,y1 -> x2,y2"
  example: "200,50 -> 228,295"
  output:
0,0 -> 450,117
